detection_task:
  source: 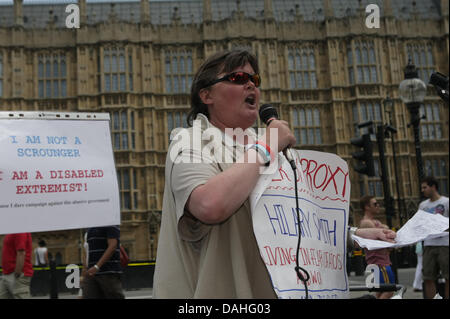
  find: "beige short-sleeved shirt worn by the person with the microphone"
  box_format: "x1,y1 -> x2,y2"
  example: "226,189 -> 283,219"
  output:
153,114 -> 276,298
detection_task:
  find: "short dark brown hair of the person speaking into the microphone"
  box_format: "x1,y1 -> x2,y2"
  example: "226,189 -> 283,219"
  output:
187,50 -> 259,126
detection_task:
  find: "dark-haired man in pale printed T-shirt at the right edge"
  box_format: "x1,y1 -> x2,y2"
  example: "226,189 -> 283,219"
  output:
419,177 -> 449,299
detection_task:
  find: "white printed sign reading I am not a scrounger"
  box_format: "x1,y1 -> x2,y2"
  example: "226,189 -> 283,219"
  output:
0,112 -> 120,234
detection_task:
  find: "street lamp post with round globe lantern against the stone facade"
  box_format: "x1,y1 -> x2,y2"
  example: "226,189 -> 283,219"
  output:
399,58 -> 427,194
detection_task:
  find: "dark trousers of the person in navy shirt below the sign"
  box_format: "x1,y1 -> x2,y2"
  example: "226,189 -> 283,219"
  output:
82,274 -> 125,299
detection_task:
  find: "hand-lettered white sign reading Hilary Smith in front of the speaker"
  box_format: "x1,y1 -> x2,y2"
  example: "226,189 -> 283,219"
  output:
250,150 -> 350,299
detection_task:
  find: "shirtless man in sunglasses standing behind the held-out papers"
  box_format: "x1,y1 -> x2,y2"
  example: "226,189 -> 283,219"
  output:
360,195 -> 395,299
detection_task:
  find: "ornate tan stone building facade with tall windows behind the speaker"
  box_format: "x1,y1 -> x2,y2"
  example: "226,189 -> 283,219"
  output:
0,0 -> 449,264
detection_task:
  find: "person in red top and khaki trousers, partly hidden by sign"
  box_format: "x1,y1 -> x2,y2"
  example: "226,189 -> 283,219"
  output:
0,233 -> 33,299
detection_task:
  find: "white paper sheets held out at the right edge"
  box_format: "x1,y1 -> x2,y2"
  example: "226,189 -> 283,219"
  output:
352,210 -> 448,250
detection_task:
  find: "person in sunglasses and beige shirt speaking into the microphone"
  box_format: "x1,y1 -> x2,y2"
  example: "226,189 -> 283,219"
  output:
153,50 -> 398,299
